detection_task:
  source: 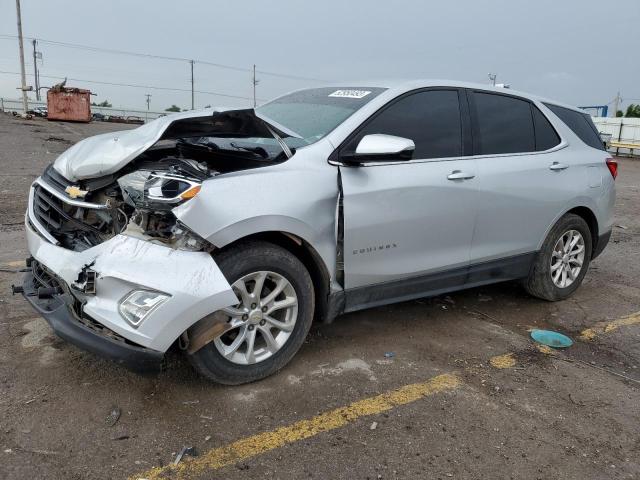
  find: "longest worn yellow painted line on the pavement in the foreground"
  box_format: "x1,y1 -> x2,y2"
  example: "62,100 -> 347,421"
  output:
130,374 -> 461,480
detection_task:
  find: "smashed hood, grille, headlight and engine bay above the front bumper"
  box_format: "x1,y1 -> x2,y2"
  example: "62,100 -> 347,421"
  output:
29,110 -> 295,251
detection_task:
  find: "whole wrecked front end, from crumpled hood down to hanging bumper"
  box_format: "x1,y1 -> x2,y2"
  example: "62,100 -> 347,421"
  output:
23,110 -> 295,370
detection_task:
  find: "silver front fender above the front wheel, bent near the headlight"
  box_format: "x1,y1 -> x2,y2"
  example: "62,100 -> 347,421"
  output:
173,163 -> 338,280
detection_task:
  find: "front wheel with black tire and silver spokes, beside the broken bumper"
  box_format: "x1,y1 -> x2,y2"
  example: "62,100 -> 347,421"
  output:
189,241 -> 314,385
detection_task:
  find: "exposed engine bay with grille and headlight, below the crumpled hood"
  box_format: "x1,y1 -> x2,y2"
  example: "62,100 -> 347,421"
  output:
33,112 -> 291,251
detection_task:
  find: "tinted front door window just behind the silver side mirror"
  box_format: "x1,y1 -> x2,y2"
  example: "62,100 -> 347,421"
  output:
343,90 -> 462,159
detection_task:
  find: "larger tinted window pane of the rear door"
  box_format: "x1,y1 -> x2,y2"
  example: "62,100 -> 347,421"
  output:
473,92 -> 536,155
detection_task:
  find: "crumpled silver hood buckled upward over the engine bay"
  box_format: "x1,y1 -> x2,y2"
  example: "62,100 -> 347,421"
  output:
53,108 -> 298,181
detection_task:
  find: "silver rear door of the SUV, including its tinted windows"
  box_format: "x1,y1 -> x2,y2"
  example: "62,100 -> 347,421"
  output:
469,91 -> 583,270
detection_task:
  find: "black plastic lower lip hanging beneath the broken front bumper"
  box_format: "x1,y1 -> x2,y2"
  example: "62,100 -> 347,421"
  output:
22,273 -> 164,373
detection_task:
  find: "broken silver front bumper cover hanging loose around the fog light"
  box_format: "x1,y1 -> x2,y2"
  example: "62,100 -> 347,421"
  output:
25,219 -> 237,368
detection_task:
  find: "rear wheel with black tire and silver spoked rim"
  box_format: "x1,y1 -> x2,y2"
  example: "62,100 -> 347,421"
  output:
524,213 -> 592,302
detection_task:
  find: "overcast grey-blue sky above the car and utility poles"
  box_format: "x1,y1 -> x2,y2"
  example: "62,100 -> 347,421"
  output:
0,0 -> 640,111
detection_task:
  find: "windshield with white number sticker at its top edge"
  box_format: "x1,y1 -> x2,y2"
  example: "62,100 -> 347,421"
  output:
256,87 -> 386,148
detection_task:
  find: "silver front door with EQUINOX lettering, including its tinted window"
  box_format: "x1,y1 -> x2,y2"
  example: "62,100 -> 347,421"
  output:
338,89 -> 477,296
